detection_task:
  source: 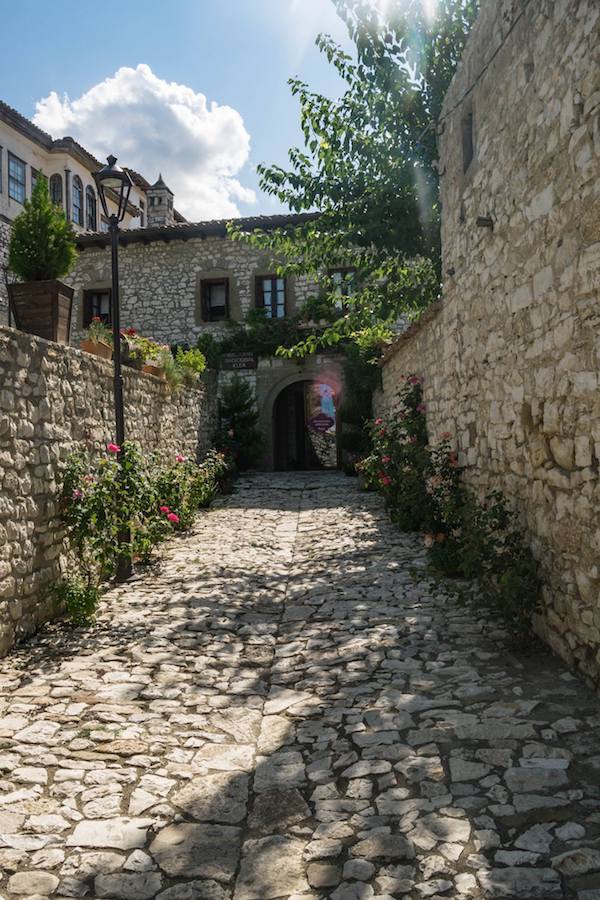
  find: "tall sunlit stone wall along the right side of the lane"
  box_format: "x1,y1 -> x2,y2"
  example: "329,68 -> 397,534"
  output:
377,0 -> 600,683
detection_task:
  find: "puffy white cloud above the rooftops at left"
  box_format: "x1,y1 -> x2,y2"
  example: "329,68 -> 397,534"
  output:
34,64 -> 254,220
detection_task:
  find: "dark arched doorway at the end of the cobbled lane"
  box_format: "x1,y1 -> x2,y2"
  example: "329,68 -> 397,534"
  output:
273,379 -> 338,472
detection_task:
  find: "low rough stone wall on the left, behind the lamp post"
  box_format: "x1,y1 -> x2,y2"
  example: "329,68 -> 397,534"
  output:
0,327 -> 216,652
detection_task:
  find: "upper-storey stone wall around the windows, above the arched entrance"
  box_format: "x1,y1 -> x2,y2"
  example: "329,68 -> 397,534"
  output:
65,237 -> 311,344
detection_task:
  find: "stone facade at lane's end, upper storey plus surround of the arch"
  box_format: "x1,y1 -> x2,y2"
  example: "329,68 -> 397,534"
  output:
67,223 -> 342,470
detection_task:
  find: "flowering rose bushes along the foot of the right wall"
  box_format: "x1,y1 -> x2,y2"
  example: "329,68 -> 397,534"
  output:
359,376 -> 541,643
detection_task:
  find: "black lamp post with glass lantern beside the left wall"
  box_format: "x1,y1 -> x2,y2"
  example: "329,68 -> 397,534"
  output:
94,156 -> 133,581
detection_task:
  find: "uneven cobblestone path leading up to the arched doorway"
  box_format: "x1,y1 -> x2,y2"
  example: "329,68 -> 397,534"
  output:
0,474 -> 600,900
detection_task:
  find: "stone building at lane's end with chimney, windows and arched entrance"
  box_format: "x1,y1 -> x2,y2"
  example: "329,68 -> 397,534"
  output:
69,212 -> 342,469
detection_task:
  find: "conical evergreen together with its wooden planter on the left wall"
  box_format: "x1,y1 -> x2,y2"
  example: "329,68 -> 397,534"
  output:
8,172 -> 77,344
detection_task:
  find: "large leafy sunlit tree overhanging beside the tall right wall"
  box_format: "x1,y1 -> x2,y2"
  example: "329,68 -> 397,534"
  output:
231,0 -> 478,354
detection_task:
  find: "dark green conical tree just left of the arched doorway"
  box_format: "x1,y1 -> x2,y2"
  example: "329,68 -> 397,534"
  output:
219,374 -> 263,472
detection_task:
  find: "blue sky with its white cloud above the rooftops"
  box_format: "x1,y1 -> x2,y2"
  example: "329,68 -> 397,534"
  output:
0,0 -> 350,218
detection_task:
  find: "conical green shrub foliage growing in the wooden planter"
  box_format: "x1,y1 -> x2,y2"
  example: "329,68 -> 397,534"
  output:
8,172 -> 77,281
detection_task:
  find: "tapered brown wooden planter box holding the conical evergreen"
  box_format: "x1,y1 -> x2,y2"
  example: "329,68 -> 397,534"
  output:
8,281 -> 74,344
